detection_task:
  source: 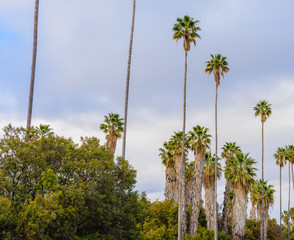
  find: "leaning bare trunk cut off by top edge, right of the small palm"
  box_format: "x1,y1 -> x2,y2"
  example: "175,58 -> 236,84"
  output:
122,0 -> 136,159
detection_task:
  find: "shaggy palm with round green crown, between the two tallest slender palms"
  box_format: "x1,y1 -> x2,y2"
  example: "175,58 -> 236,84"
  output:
188,125 -> 211,236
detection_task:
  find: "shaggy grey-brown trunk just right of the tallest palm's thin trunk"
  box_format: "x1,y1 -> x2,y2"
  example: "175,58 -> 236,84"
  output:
190,148 -> 205,236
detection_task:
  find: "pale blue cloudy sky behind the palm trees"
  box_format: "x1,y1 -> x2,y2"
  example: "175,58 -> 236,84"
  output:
0,0 -> 294,219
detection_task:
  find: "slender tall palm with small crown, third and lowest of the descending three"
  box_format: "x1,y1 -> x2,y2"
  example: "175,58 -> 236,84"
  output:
253,100 -> 272,240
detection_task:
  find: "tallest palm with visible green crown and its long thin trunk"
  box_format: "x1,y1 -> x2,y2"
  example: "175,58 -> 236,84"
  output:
173,16 -> 201,240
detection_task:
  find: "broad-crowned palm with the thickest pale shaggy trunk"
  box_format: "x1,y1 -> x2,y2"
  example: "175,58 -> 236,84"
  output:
225,152 -> 256,240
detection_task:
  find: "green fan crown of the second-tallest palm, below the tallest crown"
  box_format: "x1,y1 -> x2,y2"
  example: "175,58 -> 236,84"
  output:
205,54 -> 230,86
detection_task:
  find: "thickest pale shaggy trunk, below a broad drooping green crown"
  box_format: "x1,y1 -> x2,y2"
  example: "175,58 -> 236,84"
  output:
232,186 -> 247,240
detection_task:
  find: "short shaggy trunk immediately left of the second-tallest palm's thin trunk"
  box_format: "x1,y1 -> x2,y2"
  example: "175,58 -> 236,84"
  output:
204,182 -> 215,230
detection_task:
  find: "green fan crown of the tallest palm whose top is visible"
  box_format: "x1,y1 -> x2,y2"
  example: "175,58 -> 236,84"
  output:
173,15 -> 201,52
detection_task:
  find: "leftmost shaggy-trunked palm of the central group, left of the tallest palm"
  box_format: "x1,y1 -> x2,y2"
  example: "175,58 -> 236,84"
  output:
159,142 -> 176,201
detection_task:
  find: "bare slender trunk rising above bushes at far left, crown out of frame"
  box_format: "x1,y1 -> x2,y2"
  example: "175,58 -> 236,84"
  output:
27,0 -> 39,128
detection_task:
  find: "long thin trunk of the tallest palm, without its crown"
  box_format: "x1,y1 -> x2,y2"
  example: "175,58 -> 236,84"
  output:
178,51 -> 188,240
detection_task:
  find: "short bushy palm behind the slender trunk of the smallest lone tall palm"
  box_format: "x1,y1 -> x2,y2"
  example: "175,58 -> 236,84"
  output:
252,179 -> 275,239
